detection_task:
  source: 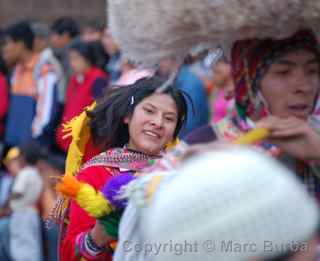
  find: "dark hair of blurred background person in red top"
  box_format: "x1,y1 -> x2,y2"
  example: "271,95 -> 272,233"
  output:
69,40 -> 109,69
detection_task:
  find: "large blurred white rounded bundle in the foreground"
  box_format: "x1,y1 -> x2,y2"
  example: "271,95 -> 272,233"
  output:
140,149 -> 319,261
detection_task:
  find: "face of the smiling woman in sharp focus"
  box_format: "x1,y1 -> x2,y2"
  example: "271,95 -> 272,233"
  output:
124,93 -> 178,155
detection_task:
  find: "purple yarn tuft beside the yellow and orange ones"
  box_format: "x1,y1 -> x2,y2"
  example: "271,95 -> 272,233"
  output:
102,171 -> 136,209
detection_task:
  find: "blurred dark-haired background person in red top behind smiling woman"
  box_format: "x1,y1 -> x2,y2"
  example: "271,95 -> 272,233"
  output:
57,41 -> 108,151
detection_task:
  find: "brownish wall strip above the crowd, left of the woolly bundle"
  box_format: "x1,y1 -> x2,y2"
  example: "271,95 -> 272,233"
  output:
0,0 -> 106,28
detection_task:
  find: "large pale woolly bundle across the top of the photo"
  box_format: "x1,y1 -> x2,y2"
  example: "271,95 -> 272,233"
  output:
108,0 -> 320,63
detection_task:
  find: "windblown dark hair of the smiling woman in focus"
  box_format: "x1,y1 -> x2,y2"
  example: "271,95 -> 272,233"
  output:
88,76 -> 187,149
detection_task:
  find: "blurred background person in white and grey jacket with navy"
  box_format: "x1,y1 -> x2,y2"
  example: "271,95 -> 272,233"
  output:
31,22 -> 65,147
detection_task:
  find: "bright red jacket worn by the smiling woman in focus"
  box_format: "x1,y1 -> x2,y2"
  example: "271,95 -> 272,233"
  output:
60,166 -> 113,261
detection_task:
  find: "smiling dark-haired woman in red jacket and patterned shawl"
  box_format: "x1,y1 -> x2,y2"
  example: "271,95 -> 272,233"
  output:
60,77 -> 187,261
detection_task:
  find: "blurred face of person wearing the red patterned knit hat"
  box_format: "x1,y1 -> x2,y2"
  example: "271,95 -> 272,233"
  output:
260,50 -> 320,119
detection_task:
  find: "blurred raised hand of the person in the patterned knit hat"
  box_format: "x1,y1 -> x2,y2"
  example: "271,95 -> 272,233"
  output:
257,116 -> 320,161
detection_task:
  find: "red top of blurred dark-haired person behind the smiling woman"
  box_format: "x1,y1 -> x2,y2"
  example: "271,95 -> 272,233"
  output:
56,67 -> 107,151
